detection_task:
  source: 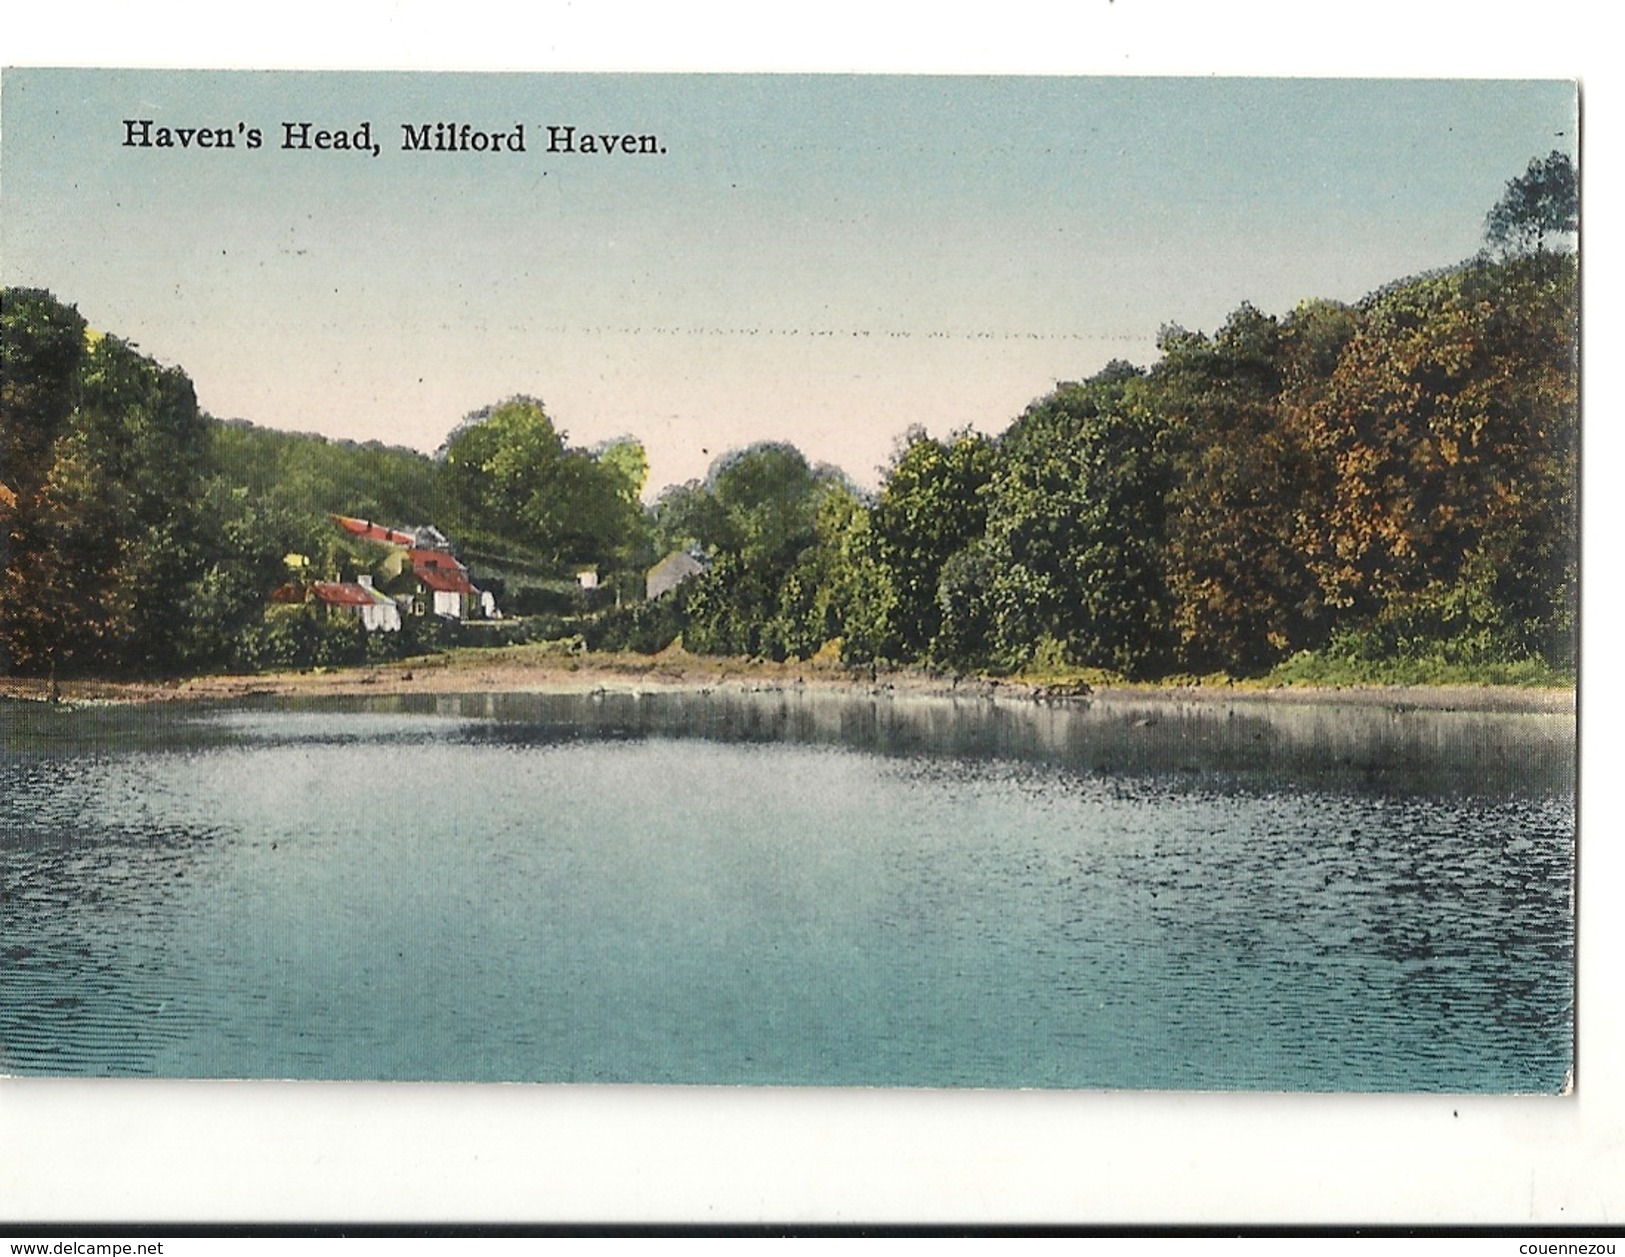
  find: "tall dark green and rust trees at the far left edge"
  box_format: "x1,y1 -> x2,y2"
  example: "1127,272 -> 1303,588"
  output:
0,291 -> 208,671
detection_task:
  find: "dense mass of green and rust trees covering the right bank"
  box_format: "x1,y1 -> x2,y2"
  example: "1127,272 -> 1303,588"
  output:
643,252 -> 1578,676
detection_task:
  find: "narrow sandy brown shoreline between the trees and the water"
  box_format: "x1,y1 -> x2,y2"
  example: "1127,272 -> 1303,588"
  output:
0,650 -> 1576,713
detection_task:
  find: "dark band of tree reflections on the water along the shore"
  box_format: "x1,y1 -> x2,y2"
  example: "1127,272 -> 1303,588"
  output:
203,689 -> 1575,794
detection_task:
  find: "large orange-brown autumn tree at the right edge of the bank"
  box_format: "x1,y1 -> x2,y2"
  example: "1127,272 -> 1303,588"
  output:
1303,255 -> 1578,664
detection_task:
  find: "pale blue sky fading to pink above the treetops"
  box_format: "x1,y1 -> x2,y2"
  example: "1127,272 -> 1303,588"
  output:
0,70 -> 1576,489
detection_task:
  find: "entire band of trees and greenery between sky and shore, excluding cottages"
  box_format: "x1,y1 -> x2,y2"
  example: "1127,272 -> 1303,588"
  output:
0,154 -> 1580,698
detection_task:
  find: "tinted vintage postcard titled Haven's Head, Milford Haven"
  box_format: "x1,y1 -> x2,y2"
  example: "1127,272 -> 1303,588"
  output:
0,70 -> 1580,1095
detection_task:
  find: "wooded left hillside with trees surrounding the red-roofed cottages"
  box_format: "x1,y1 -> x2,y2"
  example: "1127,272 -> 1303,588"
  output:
0,300 -> 647,676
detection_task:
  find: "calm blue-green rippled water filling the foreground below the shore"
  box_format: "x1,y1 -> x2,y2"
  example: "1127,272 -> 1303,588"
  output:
0,693 -> 1575,1091
